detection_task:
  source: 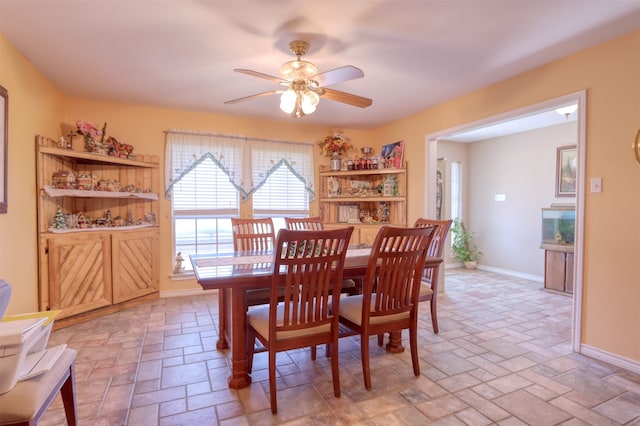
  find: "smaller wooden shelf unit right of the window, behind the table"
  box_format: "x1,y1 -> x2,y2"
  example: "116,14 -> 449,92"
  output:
319,165 -> 407,244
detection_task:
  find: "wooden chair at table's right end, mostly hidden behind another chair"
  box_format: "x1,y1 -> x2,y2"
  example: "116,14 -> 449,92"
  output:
413,218 -> 453,334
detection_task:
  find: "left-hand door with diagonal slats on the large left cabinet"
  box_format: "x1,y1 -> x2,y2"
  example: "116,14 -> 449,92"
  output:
47,233 -> 112,318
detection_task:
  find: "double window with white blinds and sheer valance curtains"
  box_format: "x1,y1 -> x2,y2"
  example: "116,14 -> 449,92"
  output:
165,131 -> 314,270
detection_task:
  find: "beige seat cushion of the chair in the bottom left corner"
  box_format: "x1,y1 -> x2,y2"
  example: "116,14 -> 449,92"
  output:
0,348 -> 76,424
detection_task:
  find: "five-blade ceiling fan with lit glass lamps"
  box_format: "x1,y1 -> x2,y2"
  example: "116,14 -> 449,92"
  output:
225,40 -> 373,118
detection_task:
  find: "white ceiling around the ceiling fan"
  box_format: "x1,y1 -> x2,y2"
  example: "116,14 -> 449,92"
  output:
0,0 -> 640,128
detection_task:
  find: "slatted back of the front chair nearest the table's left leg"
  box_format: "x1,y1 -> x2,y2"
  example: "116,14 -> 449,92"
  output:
270,227 -> 353,338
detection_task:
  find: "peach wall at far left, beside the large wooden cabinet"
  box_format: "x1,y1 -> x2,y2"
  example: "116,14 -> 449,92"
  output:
0,34 -> 63,314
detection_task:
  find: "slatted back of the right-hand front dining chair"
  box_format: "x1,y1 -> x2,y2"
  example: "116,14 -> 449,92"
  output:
363,226 -> 435,323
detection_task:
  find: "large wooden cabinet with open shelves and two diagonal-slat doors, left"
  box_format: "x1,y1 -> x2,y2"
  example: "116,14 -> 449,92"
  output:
36,136 -> 159,327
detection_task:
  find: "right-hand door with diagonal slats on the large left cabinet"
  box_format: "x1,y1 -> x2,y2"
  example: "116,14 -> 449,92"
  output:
111,228 -> 159,303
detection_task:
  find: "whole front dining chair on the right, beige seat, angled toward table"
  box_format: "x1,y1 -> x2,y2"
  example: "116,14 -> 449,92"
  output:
339,226 -> 435,390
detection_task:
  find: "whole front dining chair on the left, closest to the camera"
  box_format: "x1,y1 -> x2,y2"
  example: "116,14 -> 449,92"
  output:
247,227 -> 353,414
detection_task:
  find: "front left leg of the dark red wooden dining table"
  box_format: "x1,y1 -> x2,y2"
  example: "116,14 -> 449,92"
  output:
229,288 -> 251,389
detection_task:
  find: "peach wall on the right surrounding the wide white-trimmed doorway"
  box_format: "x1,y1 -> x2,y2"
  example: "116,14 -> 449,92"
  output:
376,31 -> 640,362
